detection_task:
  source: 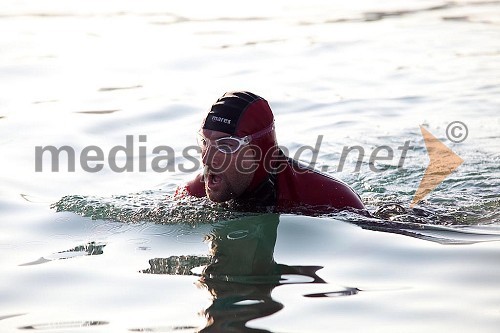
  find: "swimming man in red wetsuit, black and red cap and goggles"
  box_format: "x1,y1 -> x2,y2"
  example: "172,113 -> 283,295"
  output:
177,91 -> 365,214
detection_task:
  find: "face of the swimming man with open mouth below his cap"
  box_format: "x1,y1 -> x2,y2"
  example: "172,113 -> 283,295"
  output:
201,129 -> 257,202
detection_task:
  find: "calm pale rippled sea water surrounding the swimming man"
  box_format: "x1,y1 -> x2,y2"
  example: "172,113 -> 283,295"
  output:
0,0 -> 500,332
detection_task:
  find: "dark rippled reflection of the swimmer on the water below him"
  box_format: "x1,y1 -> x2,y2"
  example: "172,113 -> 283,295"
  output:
142,214 -> 359,332
